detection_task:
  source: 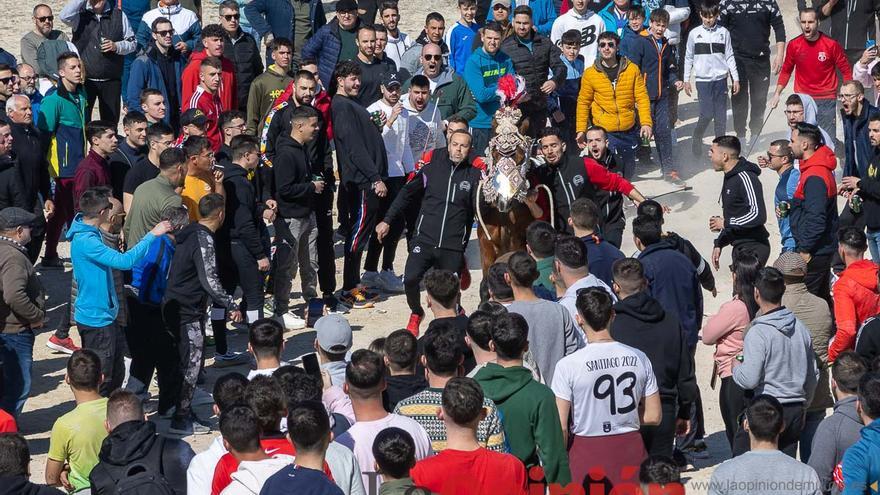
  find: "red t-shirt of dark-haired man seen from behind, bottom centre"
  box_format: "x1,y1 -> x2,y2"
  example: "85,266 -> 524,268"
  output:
410,448 -> 527,495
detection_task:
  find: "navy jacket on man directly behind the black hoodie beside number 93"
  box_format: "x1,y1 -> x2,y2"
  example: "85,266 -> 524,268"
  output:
639,239 -> 703,347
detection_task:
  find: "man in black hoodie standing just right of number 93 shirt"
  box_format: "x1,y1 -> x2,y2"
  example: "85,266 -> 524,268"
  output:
611,258 -> 699,456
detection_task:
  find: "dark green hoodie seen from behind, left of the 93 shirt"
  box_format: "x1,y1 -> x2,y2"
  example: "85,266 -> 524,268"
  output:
474,363 -> 571,485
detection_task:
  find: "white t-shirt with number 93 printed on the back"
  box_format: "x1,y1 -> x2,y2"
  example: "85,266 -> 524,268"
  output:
550,342 -> 657,437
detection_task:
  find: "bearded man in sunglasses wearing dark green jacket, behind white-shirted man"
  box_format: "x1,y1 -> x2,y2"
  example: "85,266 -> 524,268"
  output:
401,43 -> 477,126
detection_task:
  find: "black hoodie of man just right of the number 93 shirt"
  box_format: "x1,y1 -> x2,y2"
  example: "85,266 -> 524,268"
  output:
611,291 -> 697,418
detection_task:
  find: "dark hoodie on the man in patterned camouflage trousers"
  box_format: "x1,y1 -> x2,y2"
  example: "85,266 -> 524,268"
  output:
162,222 -> 238,329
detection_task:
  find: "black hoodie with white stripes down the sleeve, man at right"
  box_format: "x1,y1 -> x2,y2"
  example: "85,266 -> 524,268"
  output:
715,157 -> 770,248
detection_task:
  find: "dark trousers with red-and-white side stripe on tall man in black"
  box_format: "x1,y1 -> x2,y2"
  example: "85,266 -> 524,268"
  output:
342,184 -> 381,291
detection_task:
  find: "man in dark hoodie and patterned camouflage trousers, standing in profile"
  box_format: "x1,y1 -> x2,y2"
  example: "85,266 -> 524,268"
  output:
162,193 -> 241,435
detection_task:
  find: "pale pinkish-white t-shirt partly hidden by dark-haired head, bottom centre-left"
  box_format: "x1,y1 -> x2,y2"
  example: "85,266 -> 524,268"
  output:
336,414 -> 433,493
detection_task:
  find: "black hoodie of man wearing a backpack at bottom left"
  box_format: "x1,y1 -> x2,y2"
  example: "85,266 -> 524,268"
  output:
89,421 -> 195,495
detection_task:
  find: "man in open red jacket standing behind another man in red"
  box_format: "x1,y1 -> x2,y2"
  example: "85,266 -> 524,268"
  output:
180,24 -> 238,112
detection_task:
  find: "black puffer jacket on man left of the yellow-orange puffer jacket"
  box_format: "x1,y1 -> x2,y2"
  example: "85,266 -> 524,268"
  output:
501,34 -> 568,113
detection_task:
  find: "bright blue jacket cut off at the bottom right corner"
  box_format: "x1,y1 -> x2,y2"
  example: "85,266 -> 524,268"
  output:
842,419 -> 880,495
